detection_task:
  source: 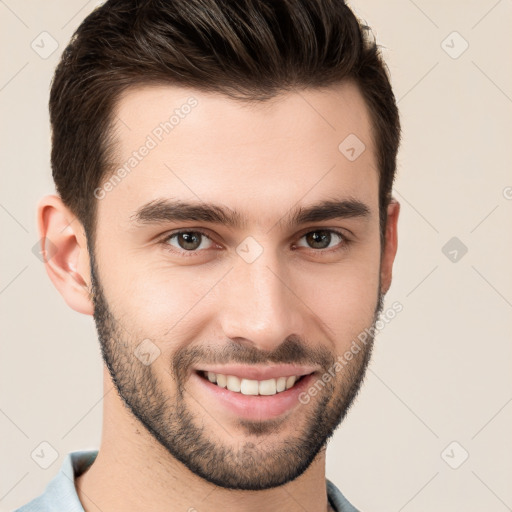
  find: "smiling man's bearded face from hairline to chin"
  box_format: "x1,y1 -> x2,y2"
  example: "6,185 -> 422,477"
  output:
91,84 -> 383,490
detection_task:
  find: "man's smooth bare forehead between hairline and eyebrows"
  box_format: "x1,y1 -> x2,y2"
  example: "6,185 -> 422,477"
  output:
98,82 -> 378,229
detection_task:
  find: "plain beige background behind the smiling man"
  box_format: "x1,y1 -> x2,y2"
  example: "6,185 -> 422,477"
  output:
0,0 -> 512,512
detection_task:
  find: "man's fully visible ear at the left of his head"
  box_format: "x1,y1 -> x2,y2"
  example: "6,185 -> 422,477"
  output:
37,195 -> 94,315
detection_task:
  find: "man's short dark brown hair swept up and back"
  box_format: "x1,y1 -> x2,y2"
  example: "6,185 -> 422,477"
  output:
49,0 -> 400,248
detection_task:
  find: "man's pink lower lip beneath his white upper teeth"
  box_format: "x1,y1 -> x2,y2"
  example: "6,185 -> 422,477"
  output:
192,372 -> 315,421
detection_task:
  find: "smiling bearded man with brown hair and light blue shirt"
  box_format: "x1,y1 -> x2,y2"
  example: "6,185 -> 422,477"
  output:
19,0 -> 400,512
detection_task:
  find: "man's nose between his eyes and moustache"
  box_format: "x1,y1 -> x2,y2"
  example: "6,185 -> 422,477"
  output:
219,250 -> 307,351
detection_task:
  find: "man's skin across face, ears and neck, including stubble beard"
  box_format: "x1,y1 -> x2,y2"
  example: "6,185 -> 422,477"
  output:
38,83 -> 399,512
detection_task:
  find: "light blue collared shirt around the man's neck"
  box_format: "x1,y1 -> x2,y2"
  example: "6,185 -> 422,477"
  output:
14,450 -> 358,512
